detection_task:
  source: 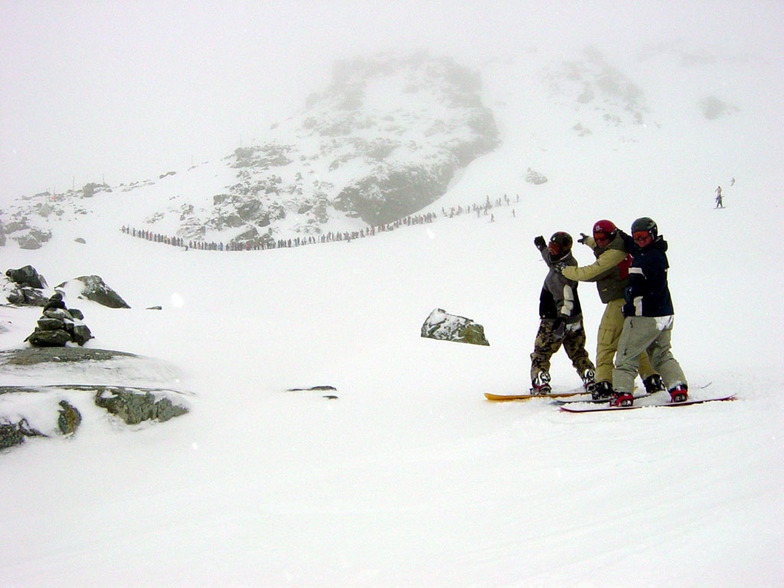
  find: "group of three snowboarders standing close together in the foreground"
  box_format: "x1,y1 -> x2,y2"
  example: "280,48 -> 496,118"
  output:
531,217 -> 688,406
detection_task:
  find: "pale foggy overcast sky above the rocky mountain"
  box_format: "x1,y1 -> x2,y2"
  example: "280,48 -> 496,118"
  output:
0,0 -> 784,204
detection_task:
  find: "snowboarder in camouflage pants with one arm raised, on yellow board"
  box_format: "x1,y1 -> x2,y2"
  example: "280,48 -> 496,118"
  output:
531,232 -> 594,394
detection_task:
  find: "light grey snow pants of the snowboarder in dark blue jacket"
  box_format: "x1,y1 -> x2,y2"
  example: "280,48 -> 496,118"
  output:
613,316 -> 688,394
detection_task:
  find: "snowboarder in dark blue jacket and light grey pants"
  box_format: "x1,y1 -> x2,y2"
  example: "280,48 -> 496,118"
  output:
611,217 -> 689,406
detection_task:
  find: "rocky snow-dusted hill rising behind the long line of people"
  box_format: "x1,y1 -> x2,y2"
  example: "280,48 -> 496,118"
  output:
0,53 -> 498,248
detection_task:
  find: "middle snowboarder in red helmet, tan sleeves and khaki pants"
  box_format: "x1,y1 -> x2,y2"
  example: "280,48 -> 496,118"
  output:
563,220 -> 664,400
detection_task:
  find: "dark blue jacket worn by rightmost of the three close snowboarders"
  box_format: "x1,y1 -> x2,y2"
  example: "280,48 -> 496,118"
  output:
623,237 -> 675,316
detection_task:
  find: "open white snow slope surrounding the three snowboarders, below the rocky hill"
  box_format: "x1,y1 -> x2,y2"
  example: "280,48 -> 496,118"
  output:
0,43 -> 784,586
